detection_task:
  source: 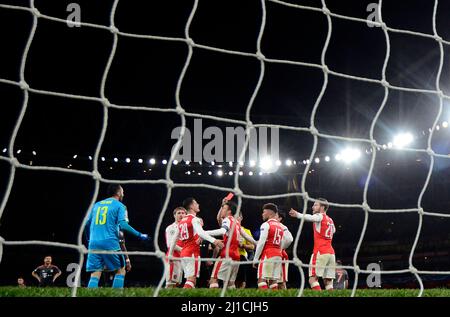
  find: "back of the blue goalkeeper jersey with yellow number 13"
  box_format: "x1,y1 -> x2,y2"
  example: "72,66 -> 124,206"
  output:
89,198 -> 127,250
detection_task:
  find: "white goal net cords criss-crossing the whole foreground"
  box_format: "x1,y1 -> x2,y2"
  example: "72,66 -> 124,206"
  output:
0,0 -> 450,296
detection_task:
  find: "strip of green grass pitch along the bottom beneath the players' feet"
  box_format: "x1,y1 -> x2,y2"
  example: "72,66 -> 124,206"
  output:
0,287 -> 450,297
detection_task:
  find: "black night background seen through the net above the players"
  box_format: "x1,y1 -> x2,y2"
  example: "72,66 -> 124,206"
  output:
0,0 -> 450,284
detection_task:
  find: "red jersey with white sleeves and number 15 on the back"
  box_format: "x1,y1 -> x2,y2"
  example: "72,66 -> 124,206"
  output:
255,219 -> 284,260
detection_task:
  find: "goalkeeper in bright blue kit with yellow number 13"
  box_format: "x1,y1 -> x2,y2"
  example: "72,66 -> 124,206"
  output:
86,184 -> 149,288
